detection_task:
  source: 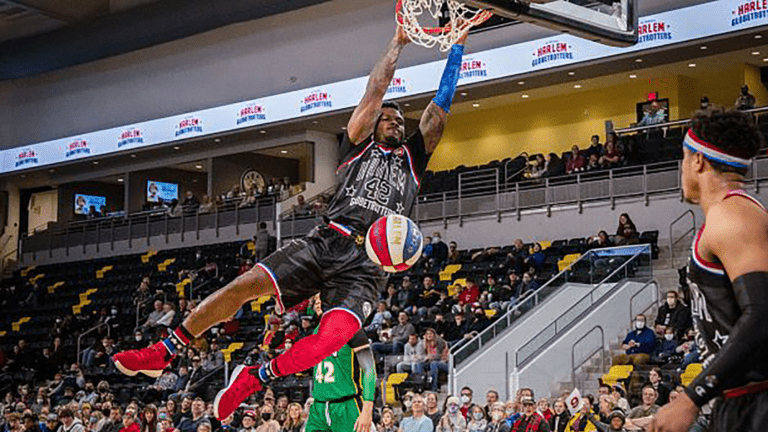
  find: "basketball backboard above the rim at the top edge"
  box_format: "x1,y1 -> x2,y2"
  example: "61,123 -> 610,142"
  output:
461,0 -> 638,46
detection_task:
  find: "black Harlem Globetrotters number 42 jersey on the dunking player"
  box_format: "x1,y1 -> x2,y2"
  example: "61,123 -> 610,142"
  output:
328,130 -> 429,233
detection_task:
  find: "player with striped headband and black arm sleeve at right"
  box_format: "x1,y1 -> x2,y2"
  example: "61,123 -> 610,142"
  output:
653,108 -> 768,432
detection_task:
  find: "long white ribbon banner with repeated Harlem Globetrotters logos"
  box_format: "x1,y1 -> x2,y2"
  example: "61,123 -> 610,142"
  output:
0,0 -> 768,173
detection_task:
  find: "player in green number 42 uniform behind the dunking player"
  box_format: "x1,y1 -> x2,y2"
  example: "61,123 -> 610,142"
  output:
304,298 -> 376,432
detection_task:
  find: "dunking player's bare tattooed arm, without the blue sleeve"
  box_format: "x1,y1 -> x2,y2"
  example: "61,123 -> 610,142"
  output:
347,25 -> 409,144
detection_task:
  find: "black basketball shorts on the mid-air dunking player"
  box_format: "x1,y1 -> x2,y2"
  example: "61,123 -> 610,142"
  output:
256,226 -> 387,326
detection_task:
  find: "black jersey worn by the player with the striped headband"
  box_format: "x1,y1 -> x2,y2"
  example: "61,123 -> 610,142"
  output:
688,190 -> 768,382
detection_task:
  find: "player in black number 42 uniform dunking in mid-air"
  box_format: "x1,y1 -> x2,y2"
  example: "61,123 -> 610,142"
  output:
113,17 -> 466,419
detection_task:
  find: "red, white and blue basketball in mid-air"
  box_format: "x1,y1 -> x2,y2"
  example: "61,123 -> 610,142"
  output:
365,215 -> 424,273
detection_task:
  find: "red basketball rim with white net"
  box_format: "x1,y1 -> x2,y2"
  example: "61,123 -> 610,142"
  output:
395,0 -> 493,52
